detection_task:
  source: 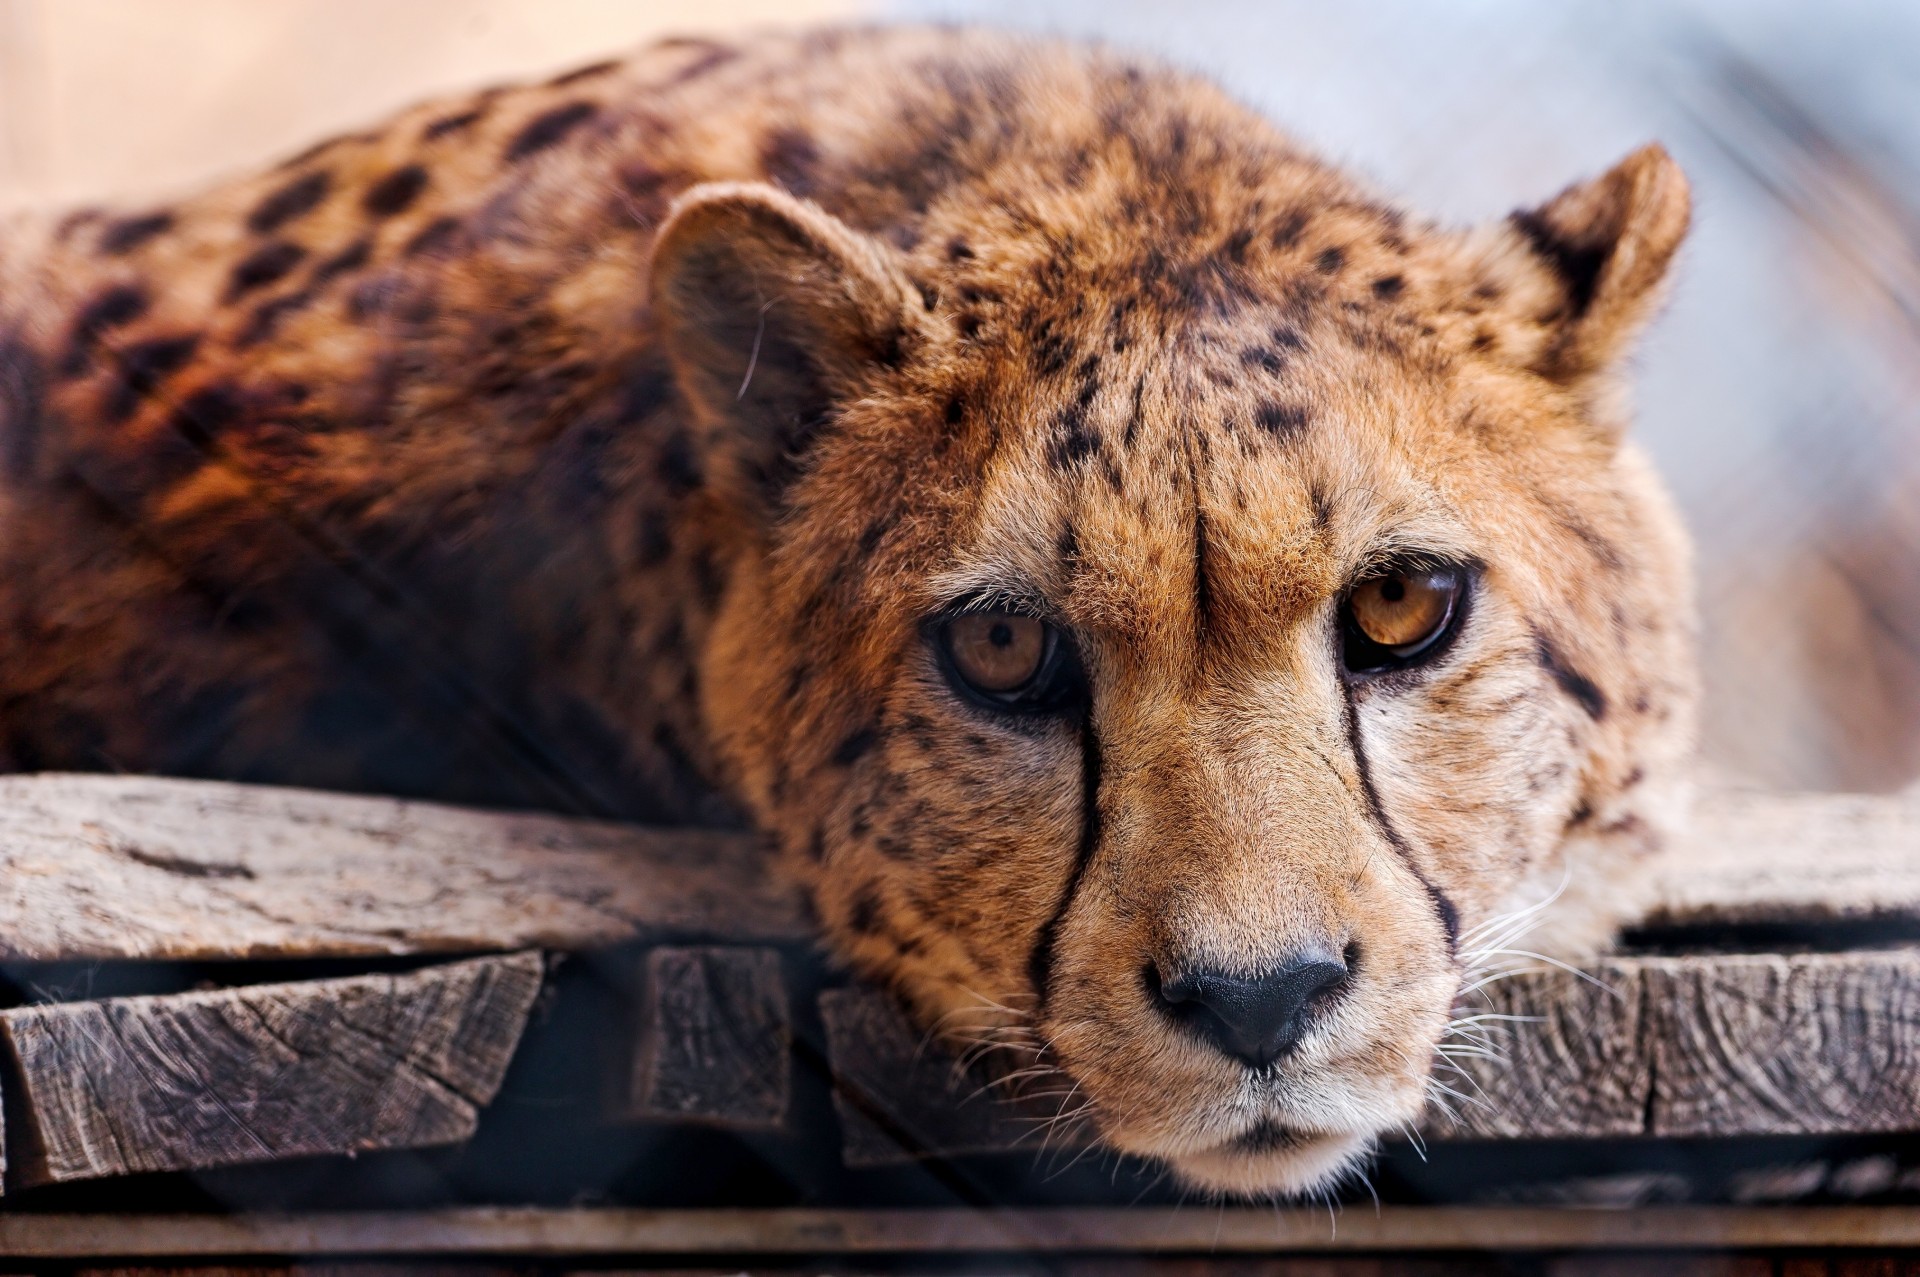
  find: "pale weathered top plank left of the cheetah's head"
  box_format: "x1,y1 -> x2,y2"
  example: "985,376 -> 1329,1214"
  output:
0,774 -> 812,960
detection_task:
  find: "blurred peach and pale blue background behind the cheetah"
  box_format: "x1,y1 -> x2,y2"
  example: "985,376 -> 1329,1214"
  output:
0,0 -> 1920,789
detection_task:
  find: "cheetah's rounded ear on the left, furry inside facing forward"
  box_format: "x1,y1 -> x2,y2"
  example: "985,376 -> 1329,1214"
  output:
649,182 -> 925,509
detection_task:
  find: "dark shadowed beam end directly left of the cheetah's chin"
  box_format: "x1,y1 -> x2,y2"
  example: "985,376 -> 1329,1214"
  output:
820,989 -> 1091,1166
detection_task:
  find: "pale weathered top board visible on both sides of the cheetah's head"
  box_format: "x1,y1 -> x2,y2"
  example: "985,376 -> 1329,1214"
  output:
0,774 -> 1920,960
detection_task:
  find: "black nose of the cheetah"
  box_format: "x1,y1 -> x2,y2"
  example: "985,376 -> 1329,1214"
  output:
1148,949 -> 1346,1068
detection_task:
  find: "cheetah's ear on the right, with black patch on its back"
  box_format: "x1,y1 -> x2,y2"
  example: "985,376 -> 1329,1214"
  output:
1490,142 -> 1692,382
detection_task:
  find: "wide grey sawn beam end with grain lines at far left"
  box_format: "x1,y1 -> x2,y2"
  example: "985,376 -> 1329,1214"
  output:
0,952 -> 543,1183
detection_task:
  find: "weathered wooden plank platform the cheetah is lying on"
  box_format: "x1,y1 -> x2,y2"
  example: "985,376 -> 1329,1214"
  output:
0,776 -> 1920,1258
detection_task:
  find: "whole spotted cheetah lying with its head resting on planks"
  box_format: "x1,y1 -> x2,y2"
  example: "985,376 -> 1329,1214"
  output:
0,29 -> 1695,1196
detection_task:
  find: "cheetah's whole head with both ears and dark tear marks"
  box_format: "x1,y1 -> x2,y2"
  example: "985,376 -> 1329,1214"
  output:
653,150 -> 1690,1194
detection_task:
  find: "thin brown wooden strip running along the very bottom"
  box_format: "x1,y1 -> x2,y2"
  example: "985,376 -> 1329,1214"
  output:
11,1206 -> 1920,1260
